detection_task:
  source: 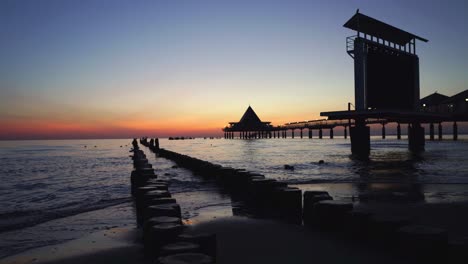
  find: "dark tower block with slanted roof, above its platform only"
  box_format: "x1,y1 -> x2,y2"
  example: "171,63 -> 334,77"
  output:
344,10 -> 427,111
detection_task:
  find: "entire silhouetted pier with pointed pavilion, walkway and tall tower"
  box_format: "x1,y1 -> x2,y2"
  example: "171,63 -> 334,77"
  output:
223,10 -> 468,157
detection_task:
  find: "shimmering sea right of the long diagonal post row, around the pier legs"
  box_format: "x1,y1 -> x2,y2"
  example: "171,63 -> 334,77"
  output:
160,135 -> 468,203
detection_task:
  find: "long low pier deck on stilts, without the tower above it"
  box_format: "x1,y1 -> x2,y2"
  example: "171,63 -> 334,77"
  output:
223,106 -> 468,144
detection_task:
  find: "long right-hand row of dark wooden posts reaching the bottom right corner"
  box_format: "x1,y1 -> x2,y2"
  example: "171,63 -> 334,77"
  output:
138,140 -> 468,263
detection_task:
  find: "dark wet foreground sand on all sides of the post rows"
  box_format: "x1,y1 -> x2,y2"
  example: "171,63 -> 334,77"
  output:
0,203 -> 468,264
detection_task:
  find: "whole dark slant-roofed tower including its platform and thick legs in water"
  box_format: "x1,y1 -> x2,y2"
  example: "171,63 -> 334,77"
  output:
321,10 -> 427,156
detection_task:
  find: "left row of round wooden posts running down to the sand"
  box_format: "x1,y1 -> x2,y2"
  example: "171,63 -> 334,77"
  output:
131,139 -> 216,264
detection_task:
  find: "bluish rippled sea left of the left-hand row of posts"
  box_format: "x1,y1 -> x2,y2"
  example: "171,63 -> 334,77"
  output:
0,140 -> 132,231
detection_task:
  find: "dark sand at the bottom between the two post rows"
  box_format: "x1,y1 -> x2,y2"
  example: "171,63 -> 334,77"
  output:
188,217 -> 412,264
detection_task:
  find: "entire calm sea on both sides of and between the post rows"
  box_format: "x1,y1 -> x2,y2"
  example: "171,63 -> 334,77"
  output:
0,136 -> 468,258
